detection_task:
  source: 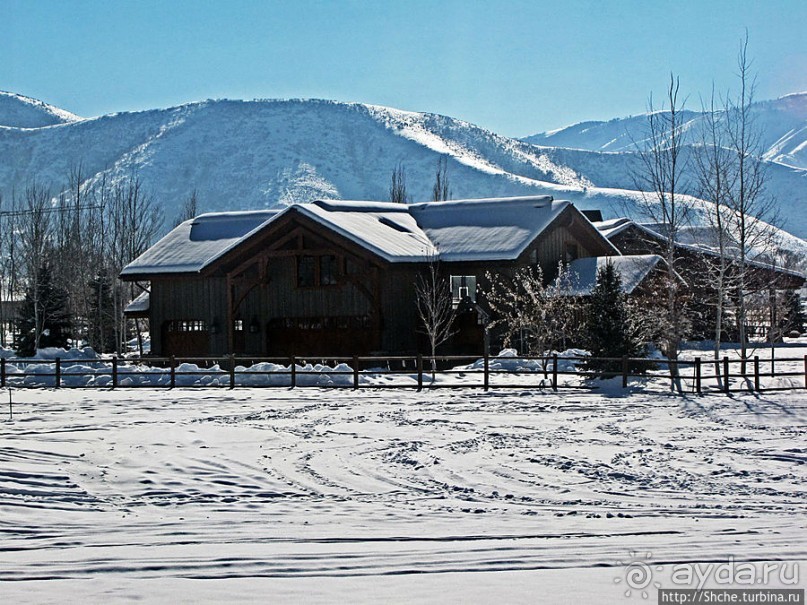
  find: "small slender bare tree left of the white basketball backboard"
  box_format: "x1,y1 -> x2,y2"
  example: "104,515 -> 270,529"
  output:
415,255 -> 456,380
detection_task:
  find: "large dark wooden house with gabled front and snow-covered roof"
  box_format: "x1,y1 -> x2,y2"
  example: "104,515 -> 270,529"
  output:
121,196 -> 619,356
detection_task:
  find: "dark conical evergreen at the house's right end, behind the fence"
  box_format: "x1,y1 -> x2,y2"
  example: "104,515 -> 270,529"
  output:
586,261 -> 645,375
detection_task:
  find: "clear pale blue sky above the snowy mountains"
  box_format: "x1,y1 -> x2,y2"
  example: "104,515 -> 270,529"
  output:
0,0 -> 807,136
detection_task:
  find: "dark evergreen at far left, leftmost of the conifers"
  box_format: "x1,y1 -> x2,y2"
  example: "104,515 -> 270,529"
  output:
17,261 -> 70,357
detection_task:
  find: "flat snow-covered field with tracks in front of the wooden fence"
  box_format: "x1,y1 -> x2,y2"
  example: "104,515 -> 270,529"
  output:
0,352 -> 807,603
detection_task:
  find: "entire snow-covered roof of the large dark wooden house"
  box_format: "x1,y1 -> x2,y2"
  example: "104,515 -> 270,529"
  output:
121,196 -> 616,277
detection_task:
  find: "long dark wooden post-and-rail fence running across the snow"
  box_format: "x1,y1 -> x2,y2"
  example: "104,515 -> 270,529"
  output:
0,355 -> 807,394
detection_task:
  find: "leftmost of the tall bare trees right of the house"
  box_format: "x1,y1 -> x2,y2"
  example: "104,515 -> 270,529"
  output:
634,74 -> 689,390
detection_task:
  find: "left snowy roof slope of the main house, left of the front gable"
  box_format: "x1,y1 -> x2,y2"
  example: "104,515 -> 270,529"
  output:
121,210 -> 278,277
